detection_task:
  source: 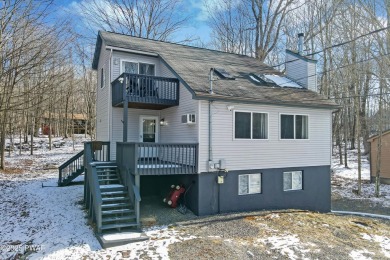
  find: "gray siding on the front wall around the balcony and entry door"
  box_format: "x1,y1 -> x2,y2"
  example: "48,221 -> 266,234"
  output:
110,48 -> 198,160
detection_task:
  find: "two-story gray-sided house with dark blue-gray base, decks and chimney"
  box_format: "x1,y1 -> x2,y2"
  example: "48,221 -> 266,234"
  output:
58,31 -> 337,246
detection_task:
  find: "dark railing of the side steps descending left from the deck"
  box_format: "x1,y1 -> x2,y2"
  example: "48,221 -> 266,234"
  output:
58,151 -> 84,186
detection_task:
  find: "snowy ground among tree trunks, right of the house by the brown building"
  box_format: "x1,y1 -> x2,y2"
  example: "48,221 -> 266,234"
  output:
332,147 -> 390,208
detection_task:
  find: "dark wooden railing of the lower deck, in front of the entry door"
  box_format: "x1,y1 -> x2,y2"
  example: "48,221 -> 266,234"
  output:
116,143 -> 198,175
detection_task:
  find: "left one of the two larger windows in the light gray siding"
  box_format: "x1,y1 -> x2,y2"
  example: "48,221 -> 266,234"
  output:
234,111 -> 268,139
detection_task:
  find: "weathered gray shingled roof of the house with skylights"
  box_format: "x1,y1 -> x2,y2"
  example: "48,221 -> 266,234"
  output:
94,31 -> 337,109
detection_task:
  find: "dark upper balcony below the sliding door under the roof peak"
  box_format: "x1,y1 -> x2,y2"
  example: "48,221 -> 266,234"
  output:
111,73 -> 179,110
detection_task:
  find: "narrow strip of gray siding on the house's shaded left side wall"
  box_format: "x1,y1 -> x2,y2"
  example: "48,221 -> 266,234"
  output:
96,43 -> 111,141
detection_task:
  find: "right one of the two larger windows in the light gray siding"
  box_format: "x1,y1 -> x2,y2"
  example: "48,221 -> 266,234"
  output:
280,114 -> 309,139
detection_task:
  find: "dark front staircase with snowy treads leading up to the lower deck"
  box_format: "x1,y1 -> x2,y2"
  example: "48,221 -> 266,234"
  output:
86,162 -> 148,248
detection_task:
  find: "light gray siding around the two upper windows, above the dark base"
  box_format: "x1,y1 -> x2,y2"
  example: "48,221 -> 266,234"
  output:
199,101 -> 332,172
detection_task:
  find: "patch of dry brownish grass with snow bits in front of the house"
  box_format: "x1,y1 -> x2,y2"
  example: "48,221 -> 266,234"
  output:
169,210 -> 390,259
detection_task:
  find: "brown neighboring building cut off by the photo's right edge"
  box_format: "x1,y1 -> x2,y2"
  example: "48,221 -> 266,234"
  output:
368,130 -> 390,184
